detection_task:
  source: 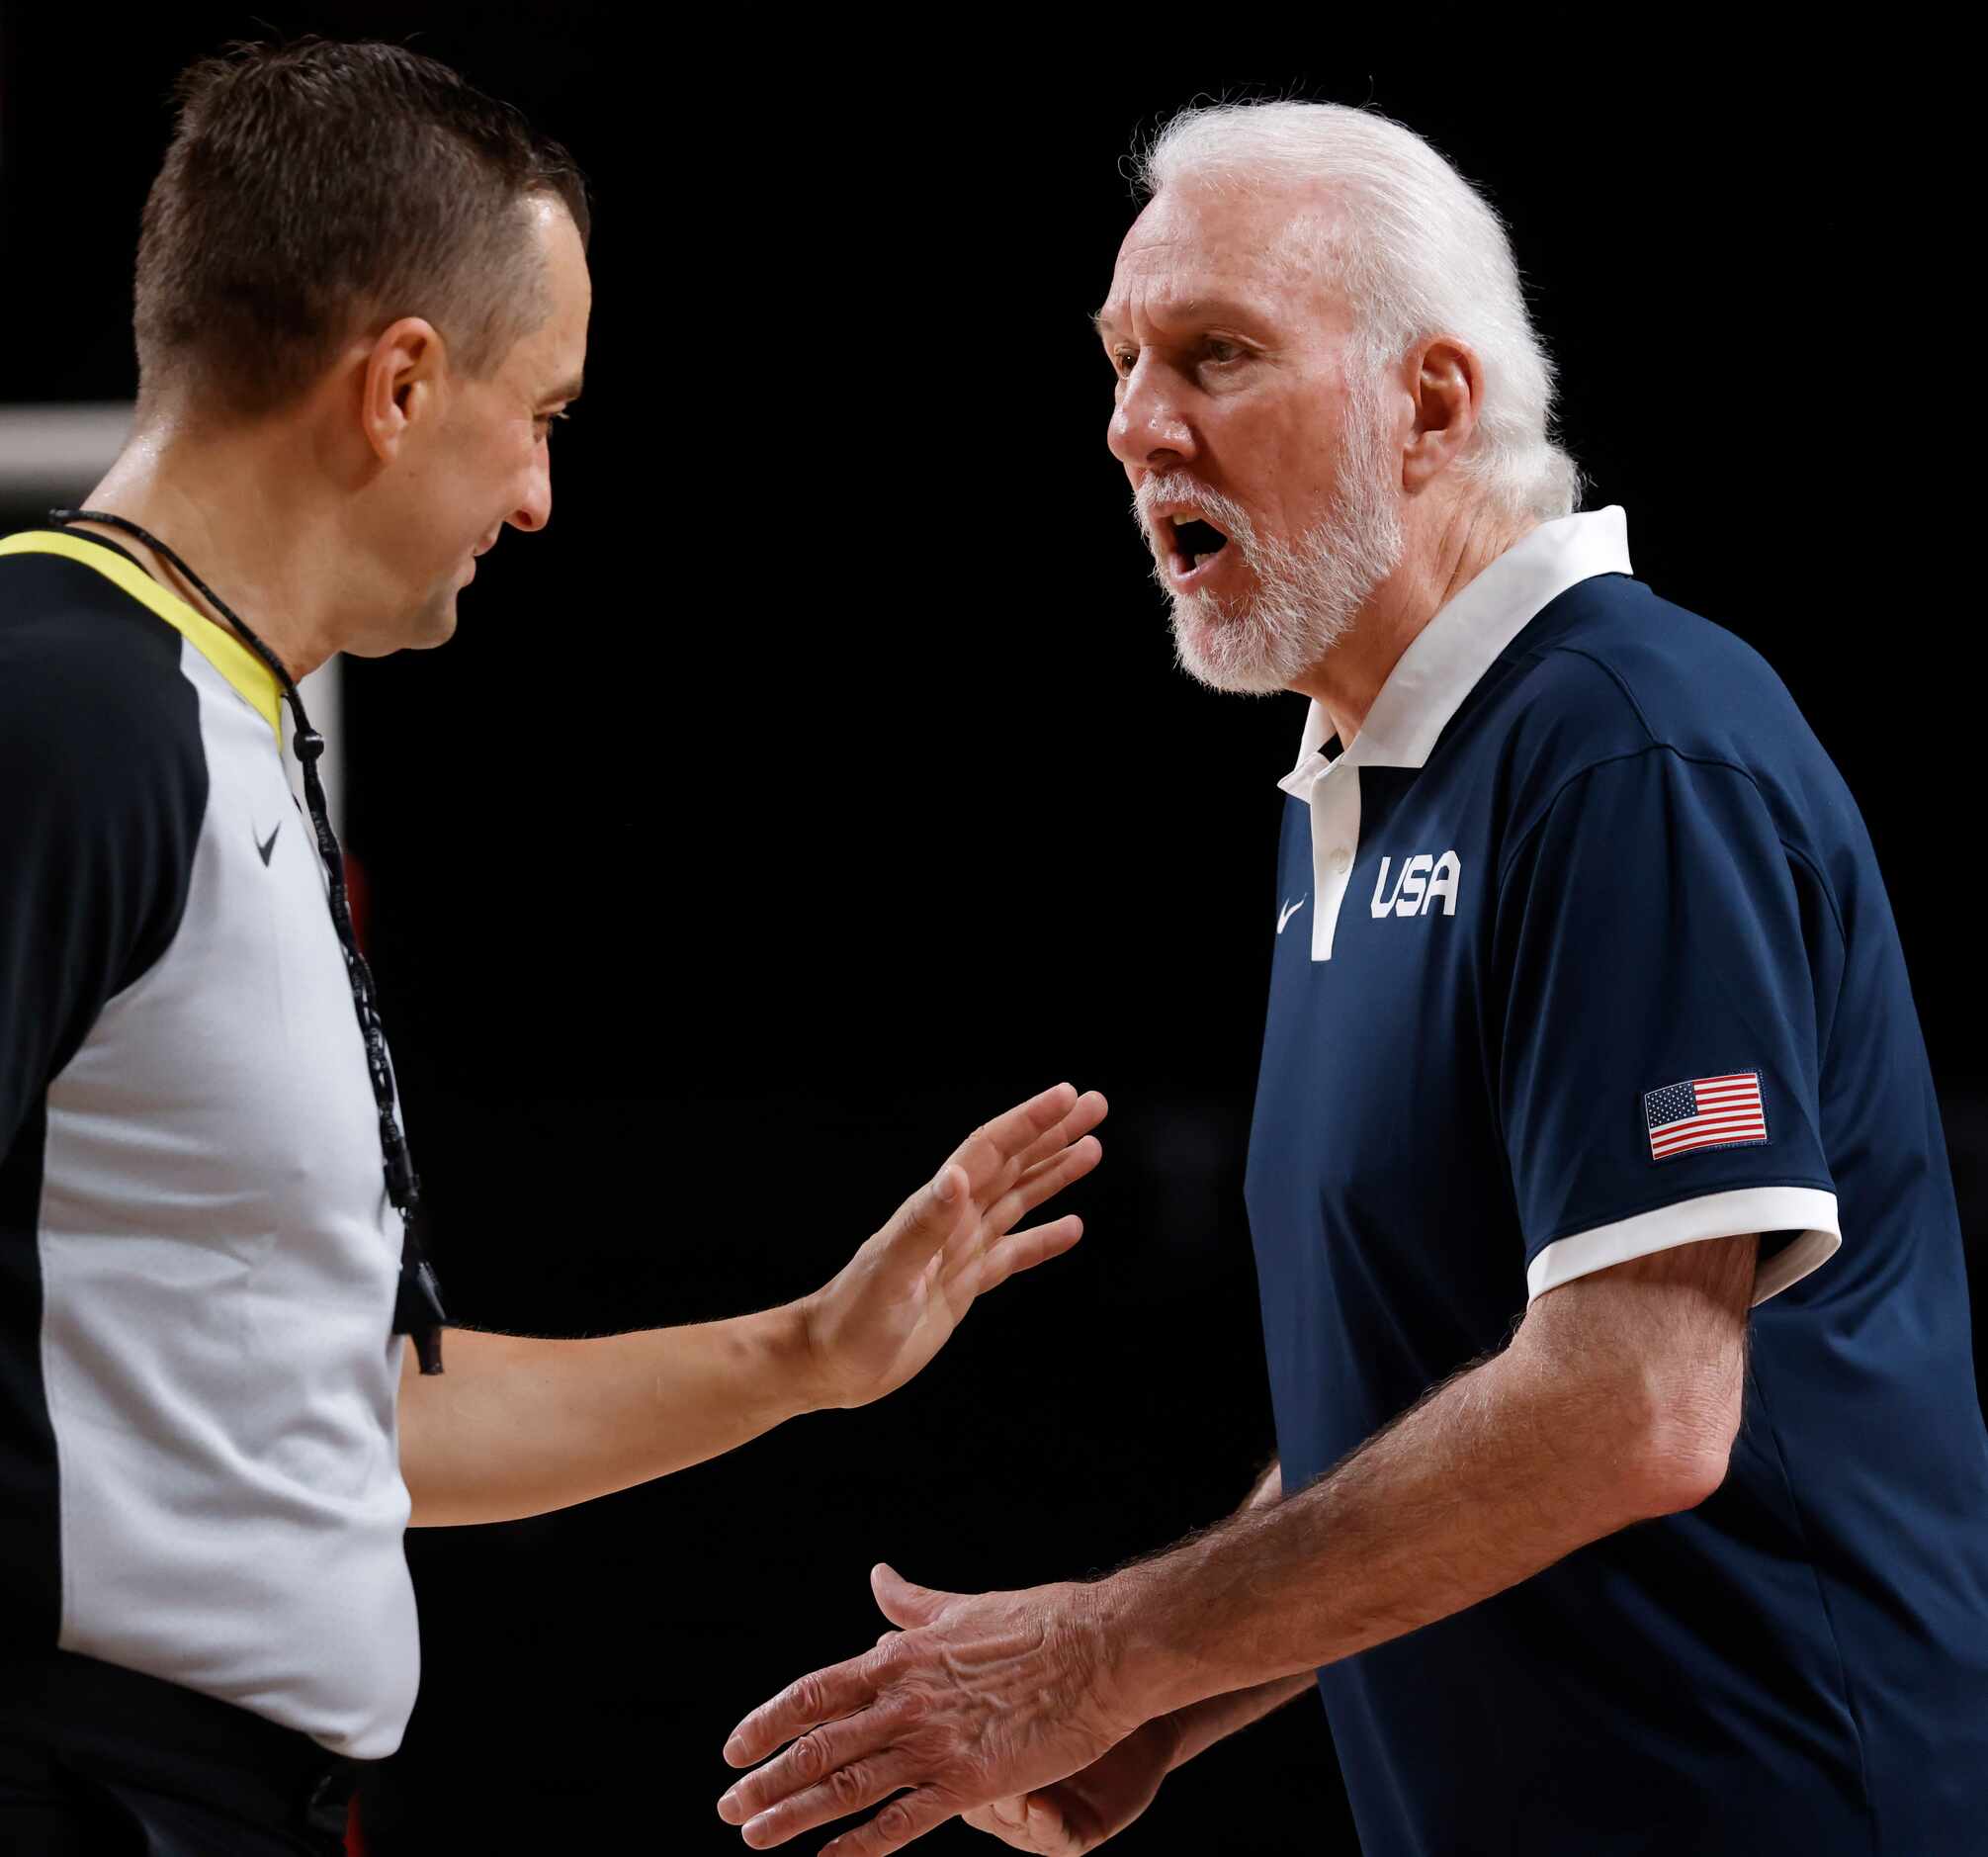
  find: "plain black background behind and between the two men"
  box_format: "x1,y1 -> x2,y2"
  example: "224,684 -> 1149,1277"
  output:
0,18 -> 1988,1857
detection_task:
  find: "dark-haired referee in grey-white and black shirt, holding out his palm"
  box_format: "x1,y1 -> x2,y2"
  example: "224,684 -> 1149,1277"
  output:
0,40 -> 1103,1857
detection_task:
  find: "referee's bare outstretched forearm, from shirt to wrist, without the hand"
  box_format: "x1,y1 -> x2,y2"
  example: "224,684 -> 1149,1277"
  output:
399,1304 -> 821,1527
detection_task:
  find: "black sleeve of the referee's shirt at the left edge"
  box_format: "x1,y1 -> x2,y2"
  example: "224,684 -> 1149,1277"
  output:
0,557 -> 207,1171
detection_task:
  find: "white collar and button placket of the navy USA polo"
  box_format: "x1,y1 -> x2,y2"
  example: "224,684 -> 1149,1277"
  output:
1278,505 -> 1630,960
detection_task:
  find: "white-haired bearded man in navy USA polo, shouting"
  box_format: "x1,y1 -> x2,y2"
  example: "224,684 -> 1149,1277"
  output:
720,104 -> 1988,1857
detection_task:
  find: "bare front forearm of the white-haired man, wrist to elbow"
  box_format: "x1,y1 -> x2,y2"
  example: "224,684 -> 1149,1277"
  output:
1093,1344 -> 1703,1733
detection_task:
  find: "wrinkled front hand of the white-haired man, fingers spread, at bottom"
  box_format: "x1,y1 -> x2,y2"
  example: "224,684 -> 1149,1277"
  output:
718,1566 -> 1141,1857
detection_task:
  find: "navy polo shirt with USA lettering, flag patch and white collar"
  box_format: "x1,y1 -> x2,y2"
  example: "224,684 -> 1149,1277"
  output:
1249,509 -> 1988,1857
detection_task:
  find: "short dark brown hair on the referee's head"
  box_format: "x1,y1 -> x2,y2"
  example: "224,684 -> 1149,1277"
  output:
133,38 -> 590,415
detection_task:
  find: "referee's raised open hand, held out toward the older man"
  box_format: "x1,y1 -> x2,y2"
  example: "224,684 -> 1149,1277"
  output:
801,1084 -> 1105,1406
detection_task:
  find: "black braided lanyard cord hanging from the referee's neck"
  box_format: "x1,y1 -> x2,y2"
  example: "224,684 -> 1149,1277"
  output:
47,509 -> 447,1373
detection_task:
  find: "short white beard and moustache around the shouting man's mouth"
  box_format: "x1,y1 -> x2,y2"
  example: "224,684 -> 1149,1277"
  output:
1133,392 -> 1404,694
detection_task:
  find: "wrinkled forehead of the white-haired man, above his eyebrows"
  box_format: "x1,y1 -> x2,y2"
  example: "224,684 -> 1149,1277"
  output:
1099,183 -> 1338,326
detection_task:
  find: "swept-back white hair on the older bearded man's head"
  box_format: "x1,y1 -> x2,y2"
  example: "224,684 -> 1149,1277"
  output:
1135,104 -> 1581,521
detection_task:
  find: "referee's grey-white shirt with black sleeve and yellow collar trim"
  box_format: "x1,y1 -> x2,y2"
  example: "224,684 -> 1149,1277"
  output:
0,533 -> 419,1757
